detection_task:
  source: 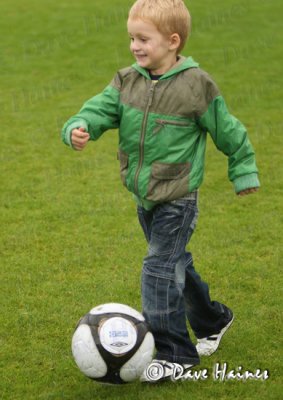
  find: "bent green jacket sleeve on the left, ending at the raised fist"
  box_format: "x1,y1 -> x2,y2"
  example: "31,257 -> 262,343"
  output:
61,80 -> 120,146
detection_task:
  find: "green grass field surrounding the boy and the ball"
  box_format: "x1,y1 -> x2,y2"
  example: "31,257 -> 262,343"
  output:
0,0 -> 283,400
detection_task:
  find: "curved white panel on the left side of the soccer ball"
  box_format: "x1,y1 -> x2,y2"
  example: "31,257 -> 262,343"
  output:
72,324 -> 107,378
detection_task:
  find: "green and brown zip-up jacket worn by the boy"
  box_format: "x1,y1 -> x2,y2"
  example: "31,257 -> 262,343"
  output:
62,57 -> 259,209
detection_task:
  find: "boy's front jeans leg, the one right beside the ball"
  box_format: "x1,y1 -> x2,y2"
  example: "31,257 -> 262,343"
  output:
138,199 -> 199,365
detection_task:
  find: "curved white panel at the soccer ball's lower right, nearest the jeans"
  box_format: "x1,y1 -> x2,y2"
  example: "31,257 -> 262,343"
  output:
120,332 -> 155,382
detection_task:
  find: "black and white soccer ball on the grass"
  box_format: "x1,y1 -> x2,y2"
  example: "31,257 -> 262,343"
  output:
72,303 -> 154,384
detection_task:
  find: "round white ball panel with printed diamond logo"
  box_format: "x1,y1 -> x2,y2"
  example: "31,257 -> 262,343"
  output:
99,317 -> 137,355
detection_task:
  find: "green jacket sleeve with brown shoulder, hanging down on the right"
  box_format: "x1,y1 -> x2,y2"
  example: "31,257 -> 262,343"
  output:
198,74 -> 260,193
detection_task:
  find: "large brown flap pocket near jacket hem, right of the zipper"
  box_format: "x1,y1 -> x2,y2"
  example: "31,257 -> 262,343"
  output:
146,162 -> 190,202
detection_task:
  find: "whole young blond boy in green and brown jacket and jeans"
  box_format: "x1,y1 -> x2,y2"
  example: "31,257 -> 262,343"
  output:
62,0 -> 259,381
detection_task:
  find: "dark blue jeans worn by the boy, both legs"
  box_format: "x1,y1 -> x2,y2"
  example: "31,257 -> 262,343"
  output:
138,193 -> 233,365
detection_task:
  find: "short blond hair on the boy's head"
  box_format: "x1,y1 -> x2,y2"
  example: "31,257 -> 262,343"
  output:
129,0 -> 191,51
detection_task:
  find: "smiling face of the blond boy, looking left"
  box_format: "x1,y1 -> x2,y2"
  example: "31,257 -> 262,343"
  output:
128,19 -> 178,75
